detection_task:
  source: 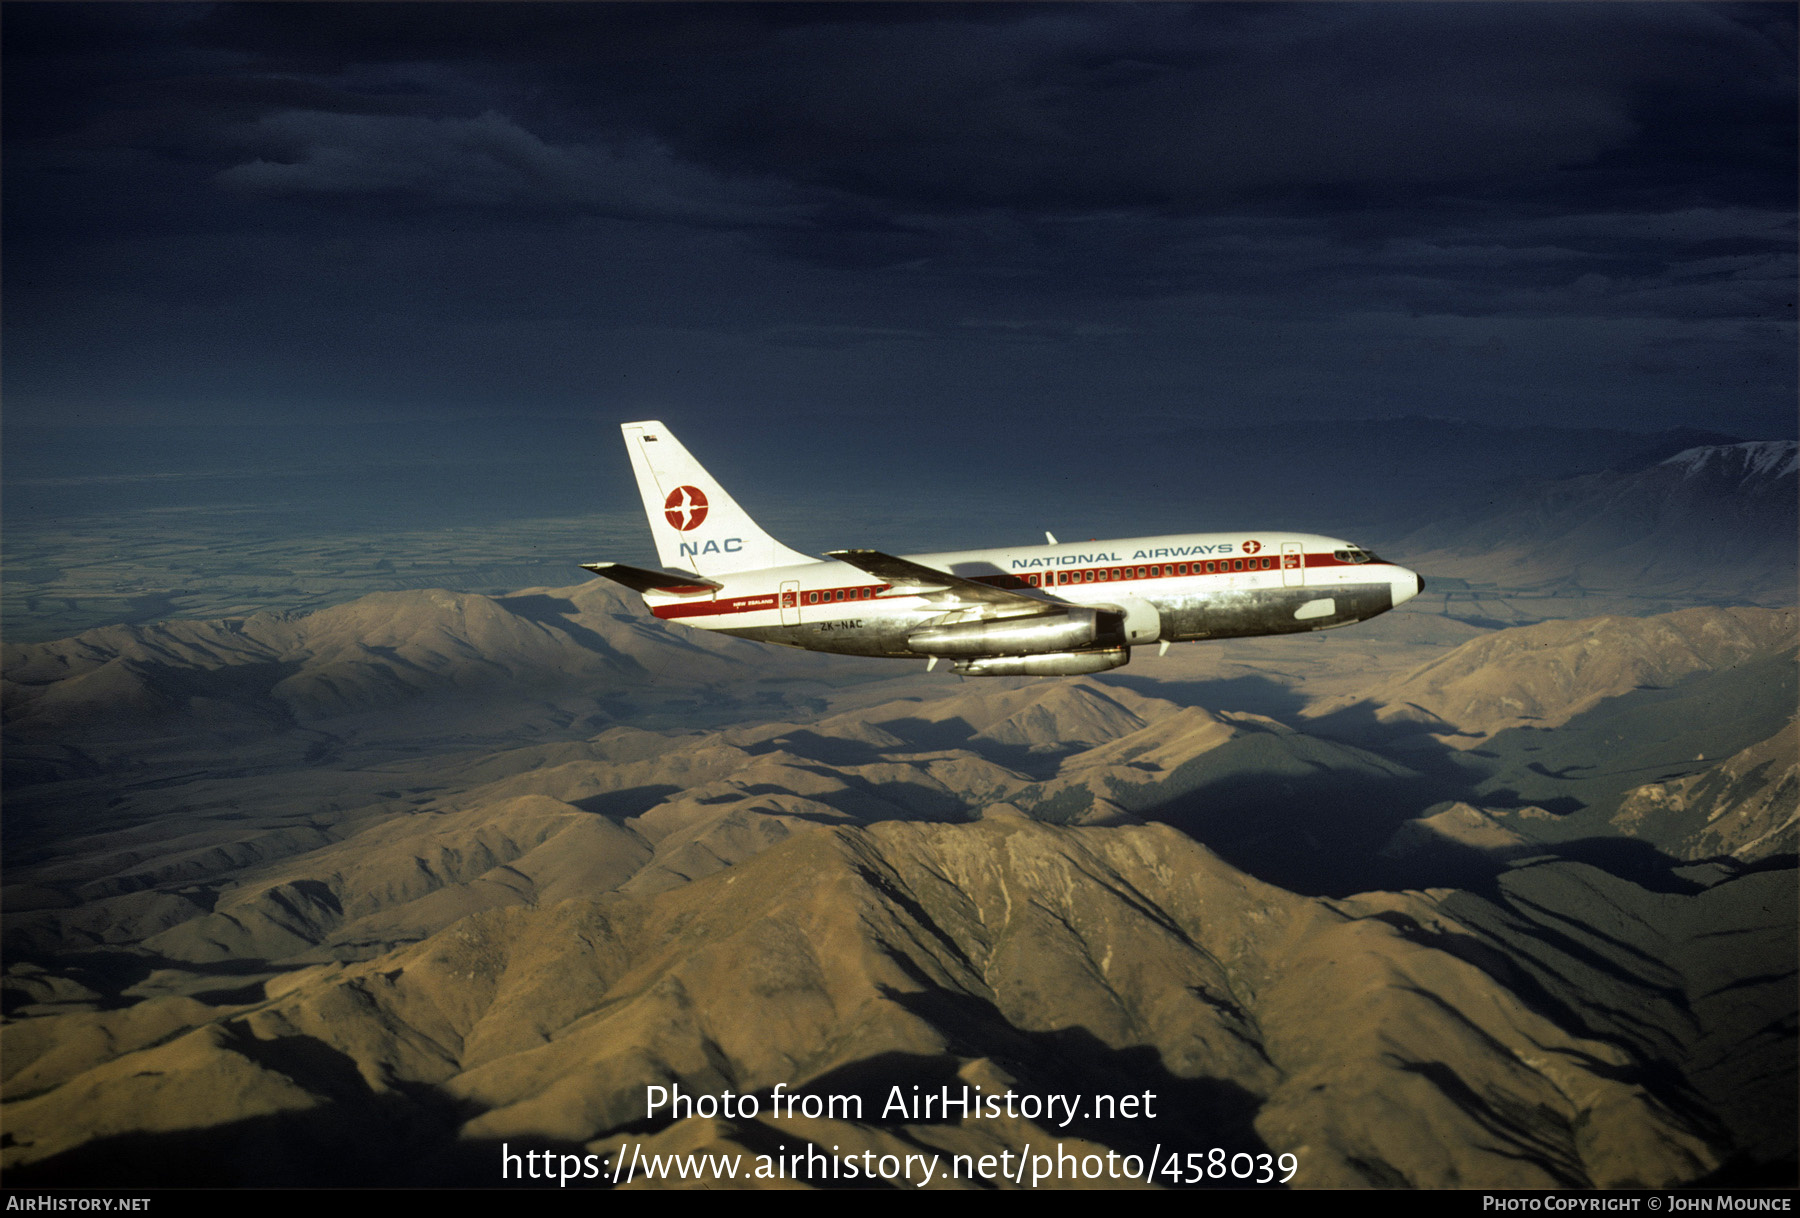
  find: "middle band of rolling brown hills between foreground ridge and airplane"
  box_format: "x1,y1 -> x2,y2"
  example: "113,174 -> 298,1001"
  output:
5,680 -> 1411,966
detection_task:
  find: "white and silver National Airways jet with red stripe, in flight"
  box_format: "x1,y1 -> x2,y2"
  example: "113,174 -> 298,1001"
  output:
581,419 -> 1426,676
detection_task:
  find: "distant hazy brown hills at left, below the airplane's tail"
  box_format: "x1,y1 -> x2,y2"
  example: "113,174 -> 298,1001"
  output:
0,579 -> 855,741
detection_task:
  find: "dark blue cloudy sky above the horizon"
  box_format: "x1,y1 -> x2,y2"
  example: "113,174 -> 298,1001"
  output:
0,4 -> 1796,444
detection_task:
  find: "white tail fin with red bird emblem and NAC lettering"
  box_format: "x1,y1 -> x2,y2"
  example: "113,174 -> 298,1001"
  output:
619,419 -> 819,576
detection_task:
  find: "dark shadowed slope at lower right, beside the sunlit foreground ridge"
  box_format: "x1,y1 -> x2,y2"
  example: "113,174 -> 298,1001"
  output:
1411,864 -> 1800,1162
